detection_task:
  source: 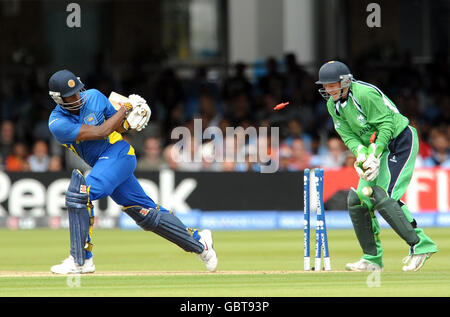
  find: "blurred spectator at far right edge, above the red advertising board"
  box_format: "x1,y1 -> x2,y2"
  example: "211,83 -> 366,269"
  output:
424,129 -> 450,168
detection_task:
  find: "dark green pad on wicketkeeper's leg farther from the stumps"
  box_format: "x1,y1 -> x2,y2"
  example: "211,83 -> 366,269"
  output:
370,185 -> 419,246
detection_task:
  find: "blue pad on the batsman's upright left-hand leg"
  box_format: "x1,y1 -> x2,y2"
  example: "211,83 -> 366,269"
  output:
66,169 -> 94,265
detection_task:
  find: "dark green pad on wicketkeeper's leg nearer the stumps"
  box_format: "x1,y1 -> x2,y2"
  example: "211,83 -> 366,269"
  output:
347,188 -> 377,255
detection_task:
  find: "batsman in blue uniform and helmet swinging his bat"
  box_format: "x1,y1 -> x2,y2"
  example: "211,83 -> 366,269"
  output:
48,70 -> 217,274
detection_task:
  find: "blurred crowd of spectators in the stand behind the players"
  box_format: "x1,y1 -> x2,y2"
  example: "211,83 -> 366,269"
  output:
0,54 -> 450,172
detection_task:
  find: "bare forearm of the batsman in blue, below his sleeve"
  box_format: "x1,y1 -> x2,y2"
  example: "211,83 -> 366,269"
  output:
77,107 -> 127,141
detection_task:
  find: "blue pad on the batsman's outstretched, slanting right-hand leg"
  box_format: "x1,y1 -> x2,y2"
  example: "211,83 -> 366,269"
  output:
123,206 -> 204,253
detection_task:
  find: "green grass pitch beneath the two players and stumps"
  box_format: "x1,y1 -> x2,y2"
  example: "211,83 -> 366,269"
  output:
0,228 -> 450,297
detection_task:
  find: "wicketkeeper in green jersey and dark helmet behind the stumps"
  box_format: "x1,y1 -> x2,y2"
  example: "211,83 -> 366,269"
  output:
316,61 -> 438,271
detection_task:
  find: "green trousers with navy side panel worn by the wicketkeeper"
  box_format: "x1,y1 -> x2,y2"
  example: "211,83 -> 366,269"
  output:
357,126 -> 438,267
